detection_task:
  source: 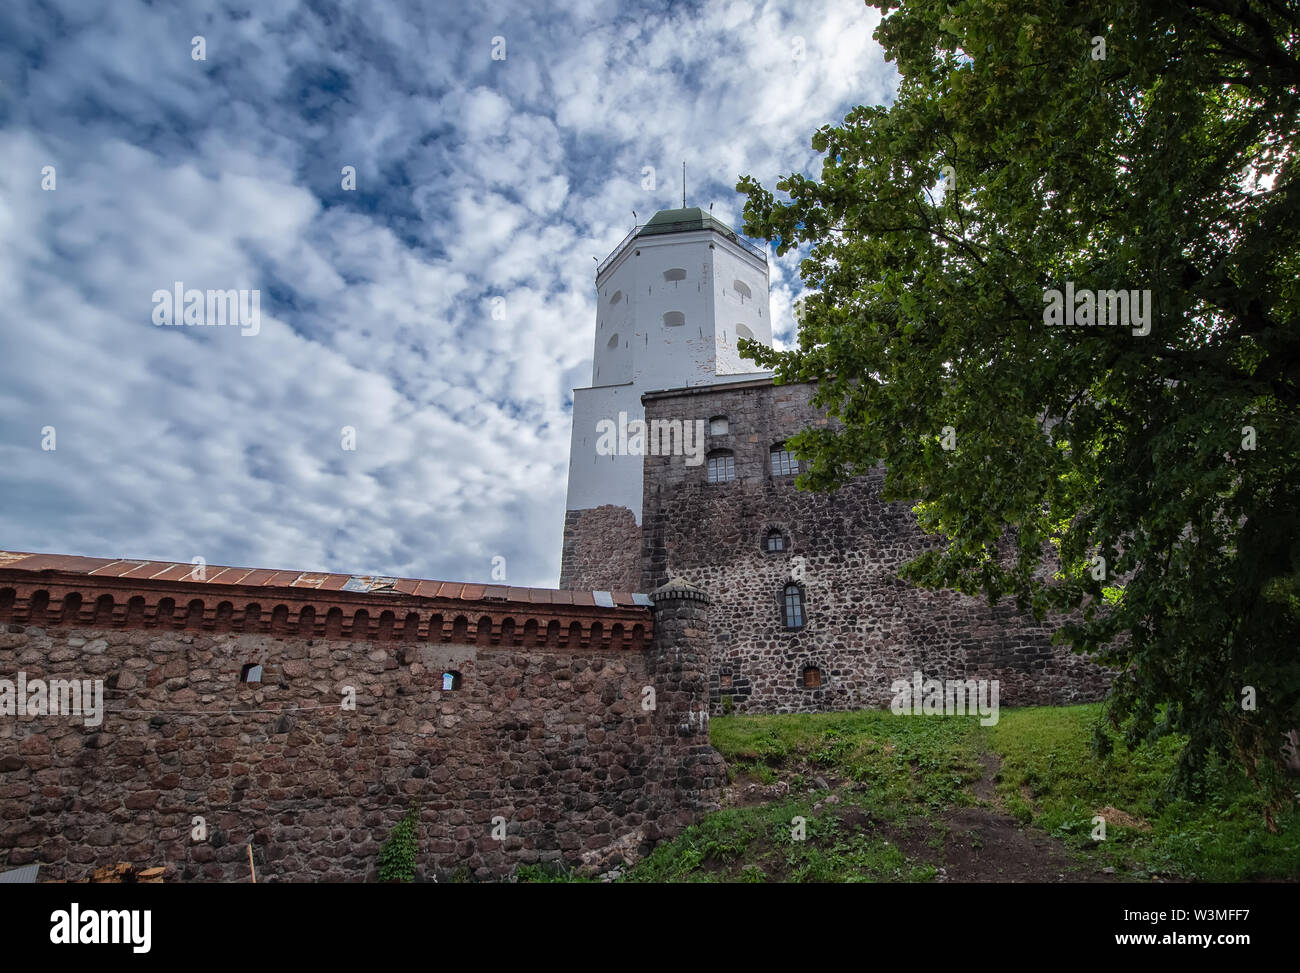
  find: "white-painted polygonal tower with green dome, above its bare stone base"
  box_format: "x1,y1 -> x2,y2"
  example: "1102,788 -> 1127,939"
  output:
566,208 -> 772,524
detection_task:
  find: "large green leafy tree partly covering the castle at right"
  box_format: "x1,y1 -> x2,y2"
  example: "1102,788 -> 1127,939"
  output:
737,0 -> 1300,827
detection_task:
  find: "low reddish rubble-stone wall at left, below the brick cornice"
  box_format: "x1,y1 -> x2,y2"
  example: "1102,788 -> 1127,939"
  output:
0,567 -> 725,882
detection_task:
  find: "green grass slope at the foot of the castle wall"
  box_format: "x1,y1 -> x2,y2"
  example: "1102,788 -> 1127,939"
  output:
620,705 -> 1300,882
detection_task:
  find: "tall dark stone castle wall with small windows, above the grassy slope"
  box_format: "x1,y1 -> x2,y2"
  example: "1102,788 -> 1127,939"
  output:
642,382 -> 1109,713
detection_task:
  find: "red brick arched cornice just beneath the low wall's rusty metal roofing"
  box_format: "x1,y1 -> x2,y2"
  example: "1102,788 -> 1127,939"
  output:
0,567 -> 654,650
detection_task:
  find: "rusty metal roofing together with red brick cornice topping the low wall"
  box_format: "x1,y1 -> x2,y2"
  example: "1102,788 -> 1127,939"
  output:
0,552 -> 654,650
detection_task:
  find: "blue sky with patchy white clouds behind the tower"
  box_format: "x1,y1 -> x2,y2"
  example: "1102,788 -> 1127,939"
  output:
0,0 -> 896,587
